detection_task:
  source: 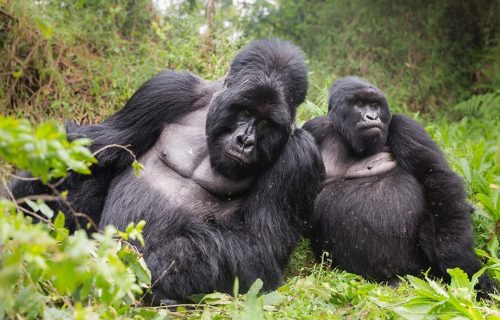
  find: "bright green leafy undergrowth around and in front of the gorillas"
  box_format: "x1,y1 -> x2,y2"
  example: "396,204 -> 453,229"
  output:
0,98 -> 500,319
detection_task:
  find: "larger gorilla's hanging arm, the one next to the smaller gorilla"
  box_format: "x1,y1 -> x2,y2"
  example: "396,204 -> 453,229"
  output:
224,129 -> 324,290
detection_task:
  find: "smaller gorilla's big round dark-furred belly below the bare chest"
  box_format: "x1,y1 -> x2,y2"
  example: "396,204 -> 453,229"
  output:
318,167 -> 424,280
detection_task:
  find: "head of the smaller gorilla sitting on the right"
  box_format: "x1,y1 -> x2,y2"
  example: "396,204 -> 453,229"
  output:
328,77 -> 391,155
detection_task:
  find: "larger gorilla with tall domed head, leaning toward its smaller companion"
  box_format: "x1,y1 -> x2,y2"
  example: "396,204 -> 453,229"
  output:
10,40 -> 324,304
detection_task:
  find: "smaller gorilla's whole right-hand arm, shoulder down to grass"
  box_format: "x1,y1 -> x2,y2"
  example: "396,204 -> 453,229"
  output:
388,115 -> 492,292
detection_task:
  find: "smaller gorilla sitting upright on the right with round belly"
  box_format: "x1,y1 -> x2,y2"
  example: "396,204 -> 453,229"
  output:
304,77 -> 492,298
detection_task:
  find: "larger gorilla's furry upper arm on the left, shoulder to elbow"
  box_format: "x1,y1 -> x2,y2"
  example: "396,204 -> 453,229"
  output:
69,71 -> 206,167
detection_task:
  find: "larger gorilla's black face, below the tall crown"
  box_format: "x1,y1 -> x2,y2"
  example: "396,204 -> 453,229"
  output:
206,82 -> 293,178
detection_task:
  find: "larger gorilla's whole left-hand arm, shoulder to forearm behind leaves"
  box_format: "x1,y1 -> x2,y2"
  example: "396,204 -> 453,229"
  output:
10,71 -> 209,230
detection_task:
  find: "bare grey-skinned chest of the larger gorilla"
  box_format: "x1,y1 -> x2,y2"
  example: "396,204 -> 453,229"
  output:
139,107 -> 251,212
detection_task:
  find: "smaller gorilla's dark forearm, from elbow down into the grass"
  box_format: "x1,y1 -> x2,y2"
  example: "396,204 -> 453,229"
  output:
419,171 -> 493,293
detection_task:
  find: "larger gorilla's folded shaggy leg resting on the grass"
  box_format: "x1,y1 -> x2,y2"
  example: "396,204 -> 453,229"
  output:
143,212 -> 282,304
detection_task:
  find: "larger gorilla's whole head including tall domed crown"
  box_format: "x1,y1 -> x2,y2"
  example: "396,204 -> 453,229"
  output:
206,39 -> 307,178
